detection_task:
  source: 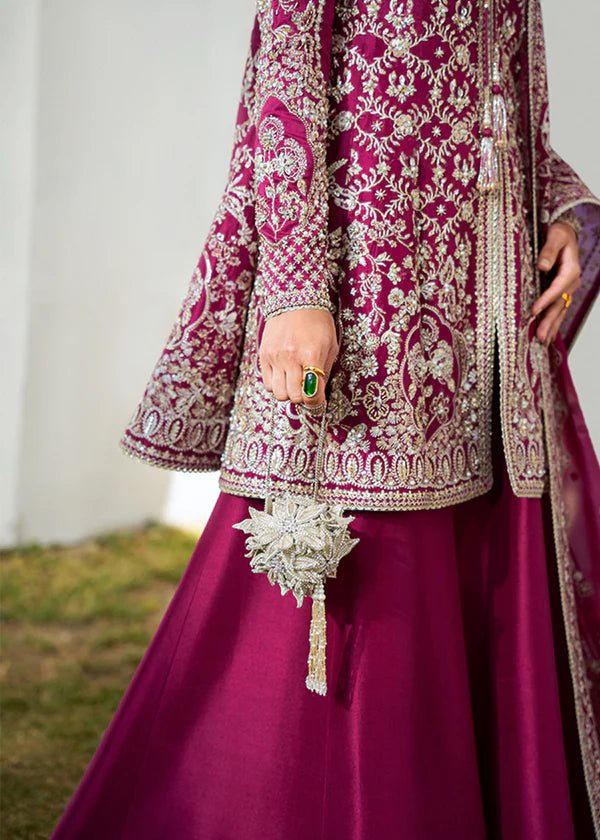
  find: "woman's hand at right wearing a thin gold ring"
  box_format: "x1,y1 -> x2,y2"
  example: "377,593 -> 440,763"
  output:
531,222 -> 581,347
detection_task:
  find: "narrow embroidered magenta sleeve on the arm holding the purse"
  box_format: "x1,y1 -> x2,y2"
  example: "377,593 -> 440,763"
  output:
254,0 -> 336,318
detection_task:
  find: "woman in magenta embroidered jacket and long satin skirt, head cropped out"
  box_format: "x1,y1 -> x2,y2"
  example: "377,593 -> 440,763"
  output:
53,0 -> 600,840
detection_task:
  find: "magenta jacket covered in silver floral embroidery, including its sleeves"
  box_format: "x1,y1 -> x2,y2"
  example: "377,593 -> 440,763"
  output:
122,0 -> 600,509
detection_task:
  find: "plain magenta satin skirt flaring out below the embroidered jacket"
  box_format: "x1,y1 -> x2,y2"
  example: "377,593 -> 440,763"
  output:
52,362 -> 594,840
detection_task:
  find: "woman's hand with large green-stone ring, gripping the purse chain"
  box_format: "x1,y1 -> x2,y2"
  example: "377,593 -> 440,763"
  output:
259,309 -> 339,406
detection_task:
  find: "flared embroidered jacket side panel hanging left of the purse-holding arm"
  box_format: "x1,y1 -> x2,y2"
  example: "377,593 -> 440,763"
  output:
120,19 -> 260,471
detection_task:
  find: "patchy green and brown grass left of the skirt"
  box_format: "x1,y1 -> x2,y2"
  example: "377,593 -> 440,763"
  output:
0,524 -> 198,840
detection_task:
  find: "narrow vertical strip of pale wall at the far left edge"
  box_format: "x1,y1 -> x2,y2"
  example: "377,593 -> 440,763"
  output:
0,0 -> 39,545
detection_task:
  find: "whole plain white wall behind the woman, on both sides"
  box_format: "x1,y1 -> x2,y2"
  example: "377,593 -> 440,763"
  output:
0,0 -> 600,545
